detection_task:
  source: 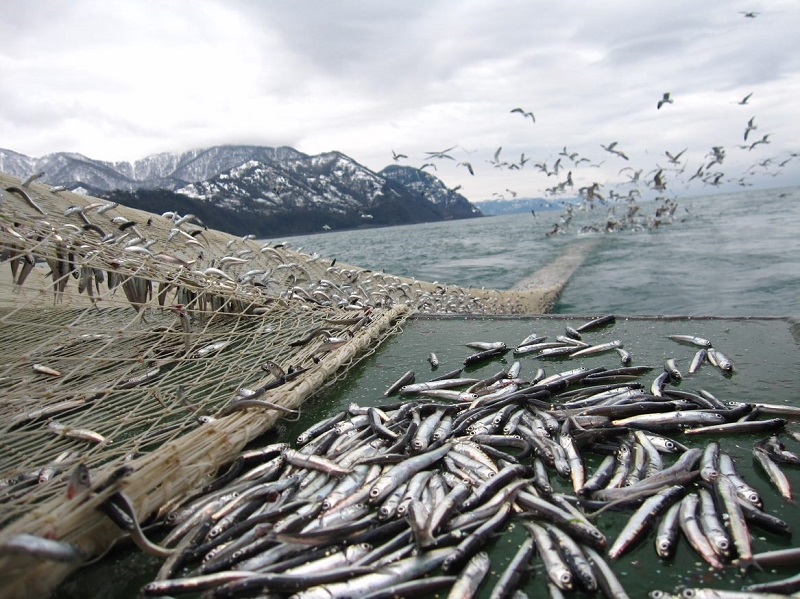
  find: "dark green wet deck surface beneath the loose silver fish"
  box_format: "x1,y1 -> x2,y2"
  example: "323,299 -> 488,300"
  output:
58,316 -> 800,598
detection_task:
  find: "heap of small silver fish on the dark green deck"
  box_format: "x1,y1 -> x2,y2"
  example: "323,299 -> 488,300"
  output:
7,316 -> 800,599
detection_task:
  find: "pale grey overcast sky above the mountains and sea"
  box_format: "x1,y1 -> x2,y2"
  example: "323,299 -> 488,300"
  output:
0,0 -> 800,201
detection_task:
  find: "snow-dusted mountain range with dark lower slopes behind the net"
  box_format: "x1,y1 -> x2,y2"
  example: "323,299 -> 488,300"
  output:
0,146 -> 482,237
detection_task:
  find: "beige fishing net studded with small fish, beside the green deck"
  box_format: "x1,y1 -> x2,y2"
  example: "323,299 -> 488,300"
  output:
0,176 -> 524,590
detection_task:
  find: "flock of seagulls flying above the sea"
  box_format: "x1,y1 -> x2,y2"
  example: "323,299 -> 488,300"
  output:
392,11 -> 800,235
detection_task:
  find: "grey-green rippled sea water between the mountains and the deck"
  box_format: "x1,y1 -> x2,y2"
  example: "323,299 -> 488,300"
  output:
280,187 -> 800,316
